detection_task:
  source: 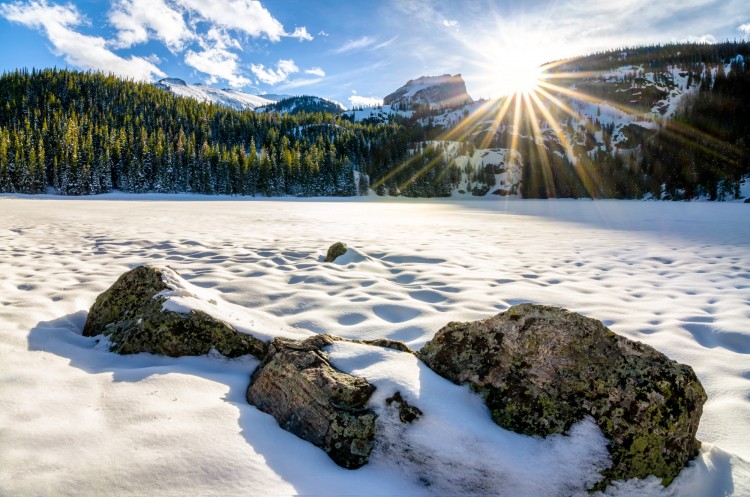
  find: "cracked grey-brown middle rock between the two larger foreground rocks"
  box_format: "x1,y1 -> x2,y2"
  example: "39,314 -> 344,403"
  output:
247,335 -> 377,469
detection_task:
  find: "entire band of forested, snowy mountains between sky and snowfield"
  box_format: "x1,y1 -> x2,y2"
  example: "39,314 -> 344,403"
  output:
0,42 -> 750,200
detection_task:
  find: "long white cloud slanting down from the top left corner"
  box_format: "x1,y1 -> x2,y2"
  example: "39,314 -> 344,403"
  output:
0,0 -> 165,81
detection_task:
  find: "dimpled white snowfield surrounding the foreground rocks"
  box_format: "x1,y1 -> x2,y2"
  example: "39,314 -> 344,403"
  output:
0,196 -> 750,497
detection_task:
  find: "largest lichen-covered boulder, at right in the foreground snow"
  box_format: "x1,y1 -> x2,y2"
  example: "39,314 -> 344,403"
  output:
419,304 -> 706,489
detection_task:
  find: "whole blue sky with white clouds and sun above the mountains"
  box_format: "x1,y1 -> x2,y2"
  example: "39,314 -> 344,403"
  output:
0,0 -> 750,106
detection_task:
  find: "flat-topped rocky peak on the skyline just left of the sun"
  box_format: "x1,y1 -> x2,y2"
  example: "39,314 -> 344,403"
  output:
383,74 -> 473,107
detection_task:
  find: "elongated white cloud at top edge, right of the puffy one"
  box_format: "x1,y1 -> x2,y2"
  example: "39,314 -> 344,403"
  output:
176,0 -> 286,41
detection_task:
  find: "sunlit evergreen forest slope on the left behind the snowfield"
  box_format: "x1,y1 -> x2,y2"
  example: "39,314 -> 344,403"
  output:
0,69 -> 420,196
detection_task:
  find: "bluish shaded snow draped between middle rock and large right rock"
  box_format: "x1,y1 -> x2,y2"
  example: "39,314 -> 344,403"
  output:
327,342 -> 609,497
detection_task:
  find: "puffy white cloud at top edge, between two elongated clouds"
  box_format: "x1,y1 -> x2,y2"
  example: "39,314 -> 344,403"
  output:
109,0 -> 195,51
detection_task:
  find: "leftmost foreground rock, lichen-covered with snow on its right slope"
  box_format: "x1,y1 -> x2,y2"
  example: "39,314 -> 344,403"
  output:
83,266 -> 266,358
